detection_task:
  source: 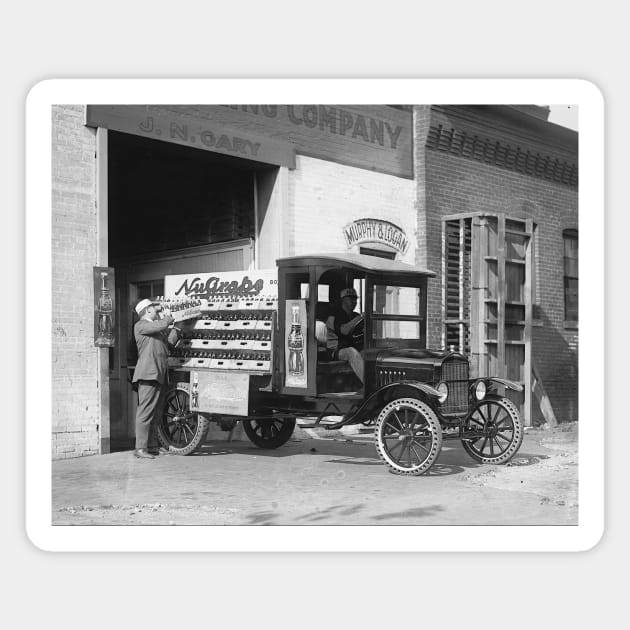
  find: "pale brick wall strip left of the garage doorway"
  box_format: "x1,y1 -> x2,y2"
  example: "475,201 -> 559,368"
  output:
52,105 -> 100,459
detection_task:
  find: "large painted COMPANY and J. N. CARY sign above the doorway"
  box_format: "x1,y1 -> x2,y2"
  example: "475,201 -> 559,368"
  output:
85,104 -> 413,179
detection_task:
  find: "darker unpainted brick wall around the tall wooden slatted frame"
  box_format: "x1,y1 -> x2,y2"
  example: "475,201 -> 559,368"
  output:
415,111 -> 578,421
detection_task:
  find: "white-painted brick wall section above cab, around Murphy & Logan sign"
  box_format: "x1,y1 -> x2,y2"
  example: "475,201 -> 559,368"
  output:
287,155 -> 416,264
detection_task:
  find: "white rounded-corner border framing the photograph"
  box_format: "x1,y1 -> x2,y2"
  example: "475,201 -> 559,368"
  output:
25,79 -> 605,552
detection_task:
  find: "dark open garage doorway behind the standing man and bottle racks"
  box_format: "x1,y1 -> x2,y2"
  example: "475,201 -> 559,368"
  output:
107,131 -> 262,451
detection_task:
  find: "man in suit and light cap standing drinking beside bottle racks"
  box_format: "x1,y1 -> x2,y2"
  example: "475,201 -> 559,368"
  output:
133,300 -> 181,459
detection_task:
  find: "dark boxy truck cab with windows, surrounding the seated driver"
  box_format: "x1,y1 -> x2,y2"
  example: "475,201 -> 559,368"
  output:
278,254 -> 435,396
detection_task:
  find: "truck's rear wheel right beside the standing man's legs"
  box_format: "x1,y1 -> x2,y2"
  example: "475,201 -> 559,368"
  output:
157,383 -> 210,455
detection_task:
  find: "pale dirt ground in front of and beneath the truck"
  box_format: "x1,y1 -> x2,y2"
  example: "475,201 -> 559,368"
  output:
52,423 -> 578,525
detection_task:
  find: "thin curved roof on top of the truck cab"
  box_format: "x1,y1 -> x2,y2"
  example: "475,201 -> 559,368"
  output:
276,253 -> 435,278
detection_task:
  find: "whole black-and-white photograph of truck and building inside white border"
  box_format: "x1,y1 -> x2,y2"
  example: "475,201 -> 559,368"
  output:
25,82 -> 604,550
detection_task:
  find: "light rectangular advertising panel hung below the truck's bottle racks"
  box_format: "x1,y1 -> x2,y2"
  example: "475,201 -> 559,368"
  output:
190,371 -> 249,416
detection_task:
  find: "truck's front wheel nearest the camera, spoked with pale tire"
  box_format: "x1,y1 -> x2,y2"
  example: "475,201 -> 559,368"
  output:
374,398 -> 442,475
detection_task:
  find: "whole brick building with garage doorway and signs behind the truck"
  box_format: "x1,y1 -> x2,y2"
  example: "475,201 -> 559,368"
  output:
52,105 -> 578,458
